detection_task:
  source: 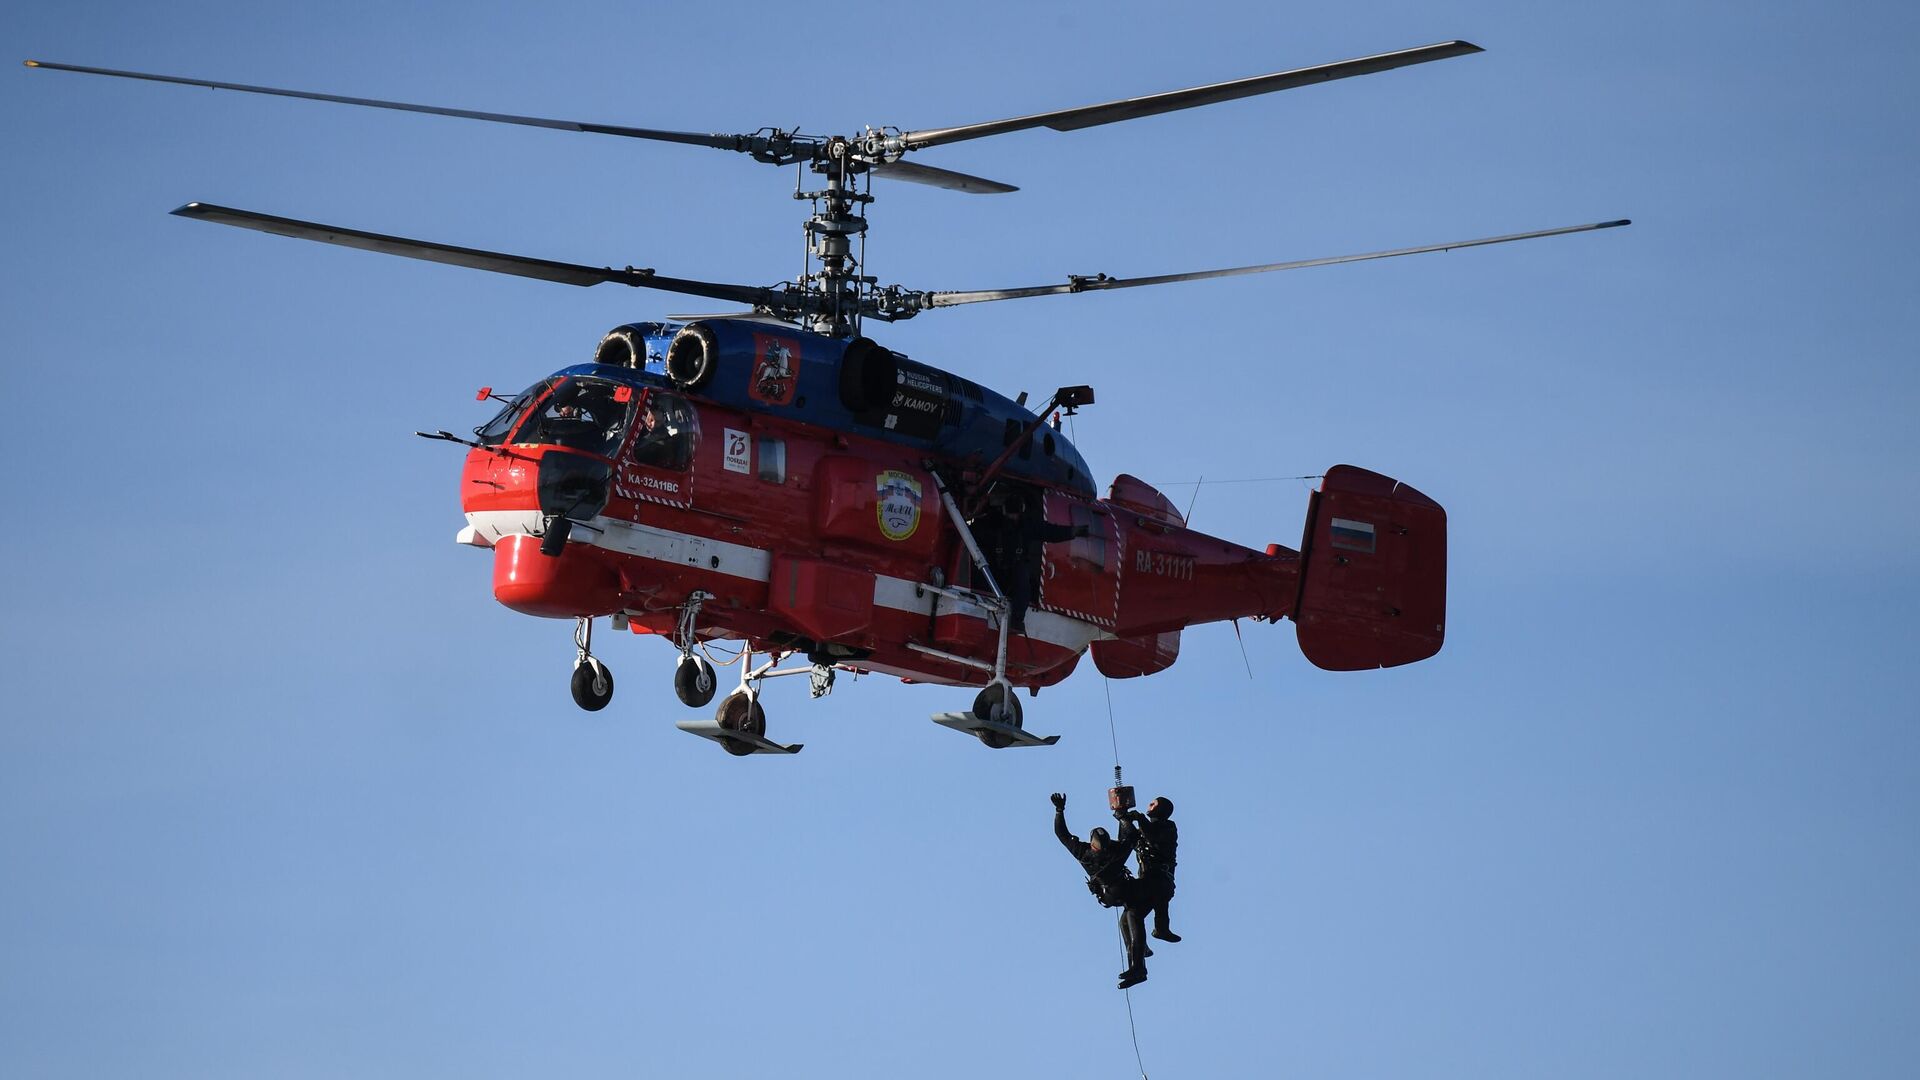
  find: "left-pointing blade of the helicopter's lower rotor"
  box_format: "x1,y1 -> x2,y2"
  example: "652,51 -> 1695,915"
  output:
173,202 -> 781,304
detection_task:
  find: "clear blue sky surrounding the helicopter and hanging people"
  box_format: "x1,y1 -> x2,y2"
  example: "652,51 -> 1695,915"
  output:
0,2 -> 1920,1078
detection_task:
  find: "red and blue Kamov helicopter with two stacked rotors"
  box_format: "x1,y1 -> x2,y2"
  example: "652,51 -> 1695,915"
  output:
25,40 -> 1628,755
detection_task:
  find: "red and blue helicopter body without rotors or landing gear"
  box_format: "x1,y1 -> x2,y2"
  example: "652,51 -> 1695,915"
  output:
449,321 -> 1444,688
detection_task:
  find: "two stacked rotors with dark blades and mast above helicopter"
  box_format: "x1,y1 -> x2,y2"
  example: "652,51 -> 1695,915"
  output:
27,40 -> 1628,336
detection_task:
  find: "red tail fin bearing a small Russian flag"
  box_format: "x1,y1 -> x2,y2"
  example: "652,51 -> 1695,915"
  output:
1292,465 -> 1446,671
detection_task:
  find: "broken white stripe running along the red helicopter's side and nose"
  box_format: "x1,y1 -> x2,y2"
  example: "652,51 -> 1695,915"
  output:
455,509 -> 1112,653
